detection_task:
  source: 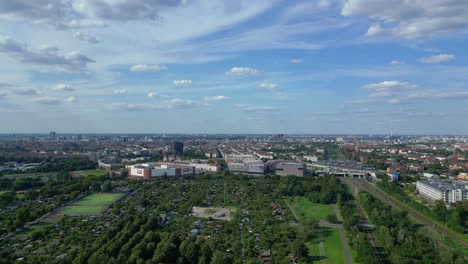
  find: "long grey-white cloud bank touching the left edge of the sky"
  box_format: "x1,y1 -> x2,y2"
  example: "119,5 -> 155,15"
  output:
0,35 -> 95,72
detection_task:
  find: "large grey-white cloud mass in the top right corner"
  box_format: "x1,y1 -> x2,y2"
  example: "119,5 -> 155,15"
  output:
341,0 -> 468,39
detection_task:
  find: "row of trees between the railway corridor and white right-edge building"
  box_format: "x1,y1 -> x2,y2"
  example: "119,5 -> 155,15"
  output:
377,181 -> 468,234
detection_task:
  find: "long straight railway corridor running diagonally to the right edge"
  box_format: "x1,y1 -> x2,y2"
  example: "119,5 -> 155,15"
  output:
340,178 -> 468,248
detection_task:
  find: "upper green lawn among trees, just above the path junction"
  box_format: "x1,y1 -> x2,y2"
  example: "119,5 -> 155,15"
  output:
291,197 -> 335,220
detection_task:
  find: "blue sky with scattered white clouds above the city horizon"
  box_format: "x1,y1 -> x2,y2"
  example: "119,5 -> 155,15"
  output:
0,0 -> 468,135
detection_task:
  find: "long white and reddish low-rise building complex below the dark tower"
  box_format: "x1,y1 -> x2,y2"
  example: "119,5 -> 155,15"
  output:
127,163 -> 195,179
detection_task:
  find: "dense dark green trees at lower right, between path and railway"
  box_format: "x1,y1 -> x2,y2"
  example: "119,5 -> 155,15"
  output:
359,192 -> 466,264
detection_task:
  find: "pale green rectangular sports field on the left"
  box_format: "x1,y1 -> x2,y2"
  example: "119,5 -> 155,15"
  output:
59,193 -> 123,214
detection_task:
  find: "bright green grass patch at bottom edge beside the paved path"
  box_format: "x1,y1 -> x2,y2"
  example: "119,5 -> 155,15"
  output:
306,227 -> 345,264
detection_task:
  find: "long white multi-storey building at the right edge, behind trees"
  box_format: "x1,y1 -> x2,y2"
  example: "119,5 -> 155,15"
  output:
416,179 -> 468,203
